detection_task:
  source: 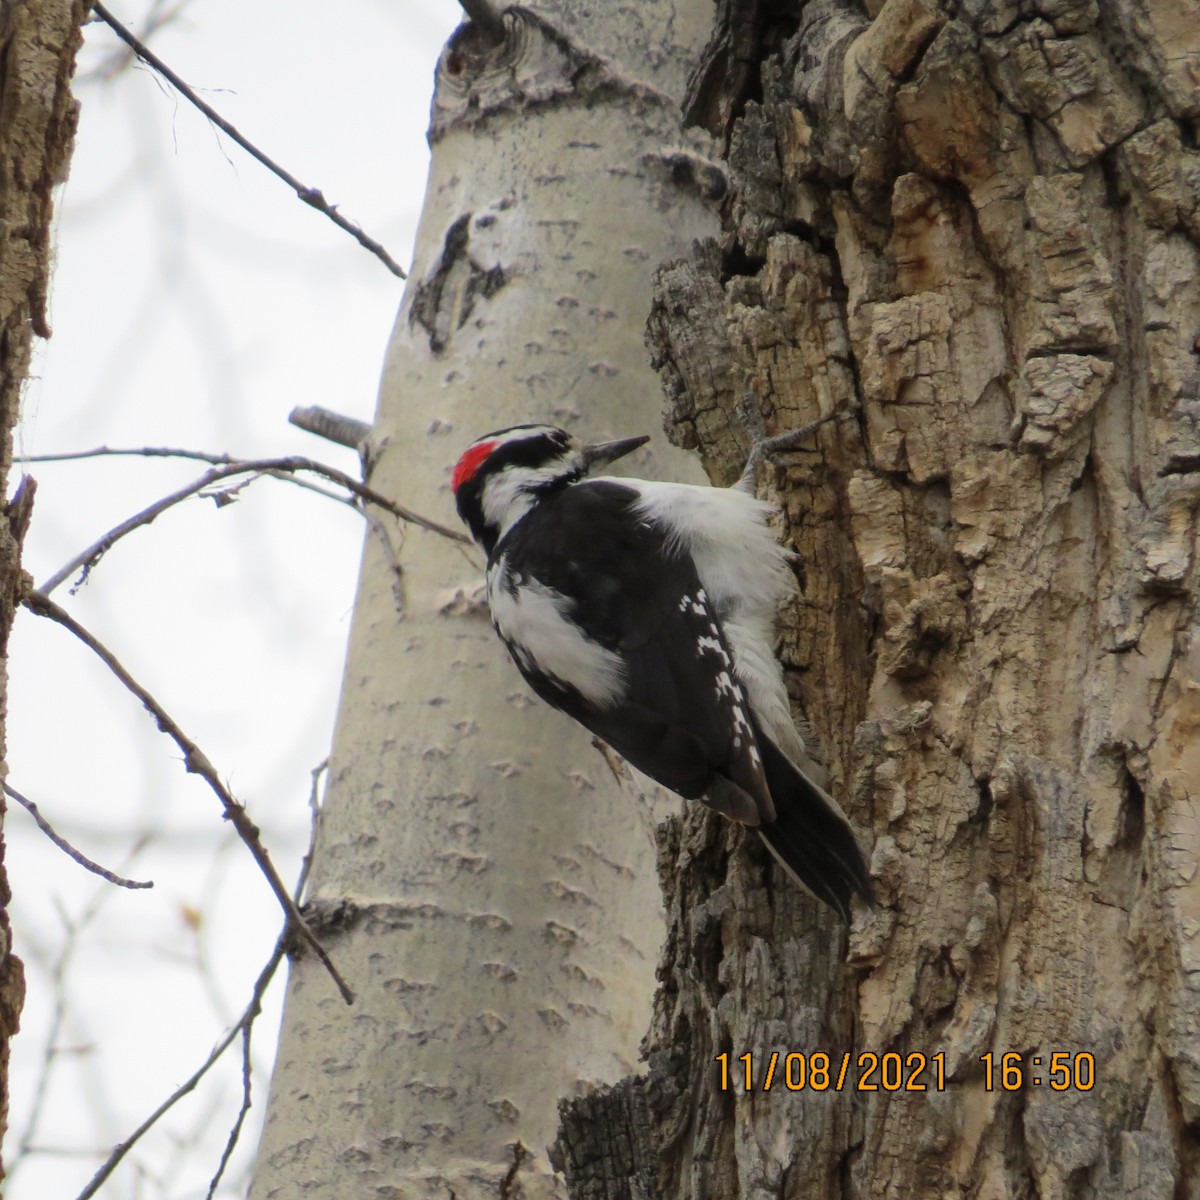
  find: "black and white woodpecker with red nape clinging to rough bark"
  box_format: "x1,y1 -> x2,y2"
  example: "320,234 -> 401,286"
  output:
451,425 -> 872,920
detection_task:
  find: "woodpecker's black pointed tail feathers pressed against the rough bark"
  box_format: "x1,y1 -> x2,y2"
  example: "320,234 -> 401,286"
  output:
758,733 -> 875,924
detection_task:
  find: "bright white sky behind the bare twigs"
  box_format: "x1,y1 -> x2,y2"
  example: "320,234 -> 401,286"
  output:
5,0 -> 458,1200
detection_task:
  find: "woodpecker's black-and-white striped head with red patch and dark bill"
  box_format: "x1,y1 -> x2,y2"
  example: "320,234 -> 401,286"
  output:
450,425 -> 650,554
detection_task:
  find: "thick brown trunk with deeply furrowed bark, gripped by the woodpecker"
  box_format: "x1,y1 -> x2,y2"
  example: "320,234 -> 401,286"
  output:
559,0 -> 1200,1200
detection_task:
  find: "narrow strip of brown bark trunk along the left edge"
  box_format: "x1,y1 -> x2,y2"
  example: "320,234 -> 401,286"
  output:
0,0 -> 86,1178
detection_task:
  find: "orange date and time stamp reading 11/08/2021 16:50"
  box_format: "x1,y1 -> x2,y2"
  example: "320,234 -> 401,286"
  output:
715,1050 -> 1096,1092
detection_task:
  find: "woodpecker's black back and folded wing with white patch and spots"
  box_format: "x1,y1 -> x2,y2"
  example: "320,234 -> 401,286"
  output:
488,480 -> 774,824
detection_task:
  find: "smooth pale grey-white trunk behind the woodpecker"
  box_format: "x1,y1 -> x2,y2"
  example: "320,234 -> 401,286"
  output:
251,0 -> 724,1200
